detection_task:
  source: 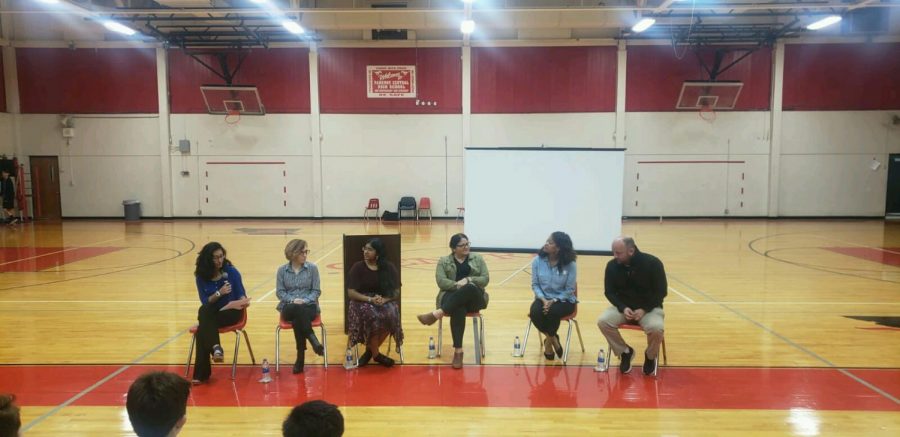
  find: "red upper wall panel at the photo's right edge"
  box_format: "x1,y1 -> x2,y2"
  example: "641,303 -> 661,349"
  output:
784,43 -> 900,111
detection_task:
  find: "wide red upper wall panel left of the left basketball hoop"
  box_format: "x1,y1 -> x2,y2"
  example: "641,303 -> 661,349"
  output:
16,48 -> 159,114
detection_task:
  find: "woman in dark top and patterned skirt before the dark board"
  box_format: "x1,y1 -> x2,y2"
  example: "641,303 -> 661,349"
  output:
347,238 -> 403,367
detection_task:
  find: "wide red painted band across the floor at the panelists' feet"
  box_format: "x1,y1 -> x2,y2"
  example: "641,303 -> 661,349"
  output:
0,365 -> 900,411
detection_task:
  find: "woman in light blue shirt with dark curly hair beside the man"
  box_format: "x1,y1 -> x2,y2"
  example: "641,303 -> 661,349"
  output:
528,231 -> 578,360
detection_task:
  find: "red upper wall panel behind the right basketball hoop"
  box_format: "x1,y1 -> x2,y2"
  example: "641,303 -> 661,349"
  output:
625,45 -> 772,112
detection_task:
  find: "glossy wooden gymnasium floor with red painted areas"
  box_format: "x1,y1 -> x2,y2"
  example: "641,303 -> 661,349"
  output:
0,216 -> 900,436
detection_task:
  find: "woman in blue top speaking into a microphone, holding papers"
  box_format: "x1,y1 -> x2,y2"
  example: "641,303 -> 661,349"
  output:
192,241 -> 250,384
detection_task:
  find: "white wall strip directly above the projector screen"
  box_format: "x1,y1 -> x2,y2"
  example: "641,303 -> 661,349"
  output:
472,113 -> 616,148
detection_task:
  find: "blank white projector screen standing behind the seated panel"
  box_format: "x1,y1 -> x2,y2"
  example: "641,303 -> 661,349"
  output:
465,147 -> 625,254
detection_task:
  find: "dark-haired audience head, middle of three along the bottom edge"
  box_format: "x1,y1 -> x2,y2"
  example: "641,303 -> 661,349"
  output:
125,372 -> 191,437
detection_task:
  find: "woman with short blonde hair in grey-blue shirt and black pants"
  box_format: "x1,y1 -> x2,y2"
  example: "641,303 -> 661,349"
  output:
275,239 -> 325,375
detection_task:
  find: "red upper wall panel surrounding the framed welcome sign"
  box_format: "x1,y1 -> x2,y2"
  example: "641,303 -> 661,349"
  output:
319,47 -> 462,114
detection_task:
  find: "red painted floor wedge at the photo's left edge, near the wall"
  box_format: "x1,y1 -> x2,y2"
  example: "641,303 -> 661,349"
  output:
0,246 -> 123,272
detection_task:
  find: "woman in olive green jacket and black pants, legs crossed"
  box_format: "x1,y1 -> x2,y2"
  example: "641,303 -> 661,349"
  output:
417,234 -> 491,369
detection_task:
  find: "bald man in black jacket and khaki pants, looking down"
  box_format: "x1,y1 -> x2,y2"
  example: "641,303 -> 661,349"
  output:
597,237 -> 668,375
